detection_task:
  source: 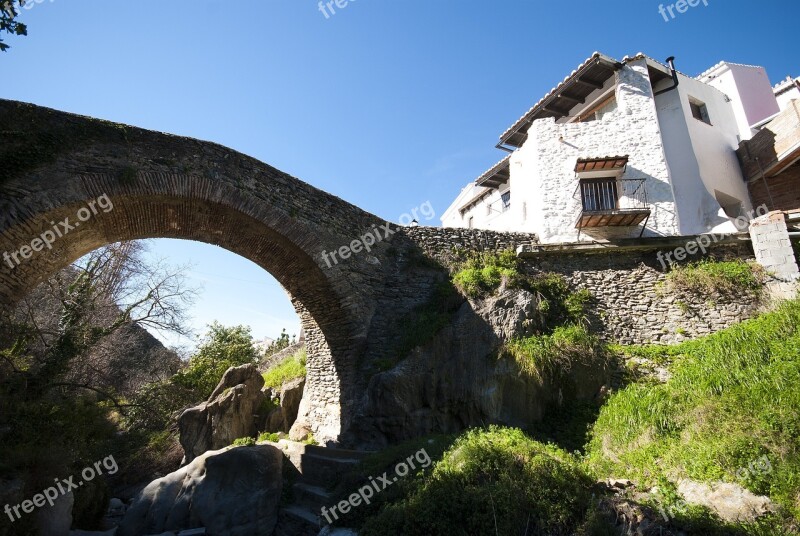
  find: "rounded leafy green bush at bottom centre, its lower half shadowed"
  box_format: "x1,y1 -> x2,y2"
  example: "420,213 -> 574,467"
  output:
360,427 -> 605,536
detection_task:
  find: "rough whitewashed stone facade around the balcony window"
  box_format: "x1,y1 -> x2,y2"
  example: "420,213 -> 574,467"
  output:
511,59 -> 678,243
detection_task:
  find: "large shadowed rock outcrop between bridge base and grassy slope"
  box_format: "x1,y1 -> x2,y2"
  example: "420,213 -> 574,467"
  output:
346,289 -> 611,448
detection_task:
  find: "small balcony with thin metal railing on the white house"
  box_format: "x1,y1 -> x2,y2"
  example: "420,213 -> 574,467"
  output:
574,178 -> 650,234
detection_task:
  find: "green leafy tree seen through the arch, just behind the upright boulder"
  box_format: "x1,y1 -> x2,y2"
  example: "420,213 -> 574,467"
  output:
172,322 -> 257,399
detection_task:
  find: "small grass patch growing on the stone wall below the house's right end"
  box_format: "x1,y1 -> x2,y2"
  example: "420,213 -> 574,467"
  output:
666,259 -> 766,298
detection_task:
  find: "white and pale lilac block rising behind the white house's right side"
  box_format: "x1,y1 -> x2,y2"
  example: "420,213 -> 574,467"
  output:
699,62 -> 780,140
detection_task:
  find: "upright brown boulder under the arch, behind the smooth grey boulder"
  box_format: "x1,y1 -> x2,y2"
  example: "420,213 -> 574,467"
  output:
178,365 -> 265,463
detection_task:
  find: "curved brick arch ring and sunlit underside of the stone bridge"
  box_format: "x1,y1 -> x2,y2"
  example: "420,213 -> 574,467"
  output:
0,173 -> 376,443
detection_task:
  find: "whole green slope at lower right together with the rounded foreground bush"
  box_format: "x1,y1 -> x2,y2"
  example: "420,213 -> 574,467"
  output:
345,301 -> 800,535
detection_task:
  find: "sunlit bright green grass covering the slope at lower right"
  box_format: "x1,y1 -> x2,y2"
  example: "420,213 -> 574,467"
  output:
587,300 -> 800,519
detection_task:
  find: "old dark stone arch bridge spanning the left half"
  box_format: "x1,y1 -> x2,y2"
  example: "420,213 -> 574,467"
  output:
0,100 -> 530,443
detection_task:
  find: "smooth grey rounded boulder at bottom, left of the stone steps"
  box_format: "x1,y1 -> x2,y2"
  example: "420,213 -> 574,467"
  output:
117,445 -> 283,536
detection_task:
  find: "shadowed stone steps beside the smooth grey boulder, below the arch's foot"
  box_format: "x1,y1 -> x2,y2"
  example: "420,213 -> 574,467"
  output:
273,439 -> 369,536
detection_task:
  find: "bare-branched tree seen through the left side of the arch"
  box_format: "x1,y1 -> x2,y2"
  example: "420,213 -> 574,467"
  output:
5,242 -> 195,398
